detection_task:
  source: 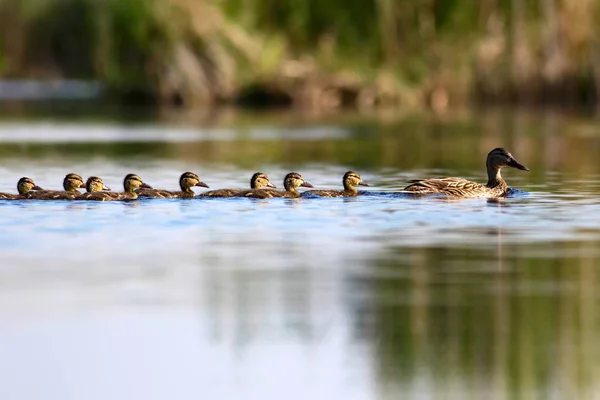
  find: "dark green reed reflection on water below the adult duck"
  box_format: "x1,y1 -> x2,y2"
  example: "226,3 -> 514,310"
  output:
357,242 -> 600,398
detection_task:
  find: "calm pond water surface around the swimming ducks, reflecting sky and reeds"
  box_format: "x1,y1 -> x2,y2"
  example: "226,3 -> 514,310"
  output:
0,111 -> 600,400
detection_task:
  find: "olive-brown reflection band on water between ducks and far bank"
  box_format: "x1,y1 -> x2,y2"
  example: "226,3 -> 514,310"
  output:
0,110 -> 600,183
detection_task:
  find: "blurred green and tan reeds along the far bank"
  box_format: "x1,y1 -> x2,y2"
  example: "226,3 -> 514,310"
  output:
0,0 -> 600,109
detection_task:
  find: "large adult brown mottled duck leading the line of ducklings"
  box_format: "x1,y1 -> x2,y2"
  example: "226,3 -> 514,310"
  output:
404,148 -> 529,198
